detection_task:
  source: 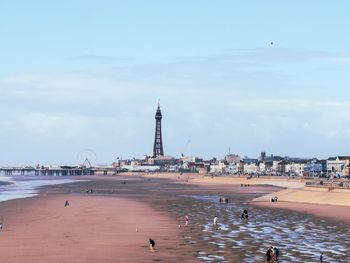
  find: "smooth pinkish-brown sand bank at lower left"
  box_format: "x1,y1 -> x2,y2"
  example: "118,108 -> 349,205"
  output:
0,195 -> 194,263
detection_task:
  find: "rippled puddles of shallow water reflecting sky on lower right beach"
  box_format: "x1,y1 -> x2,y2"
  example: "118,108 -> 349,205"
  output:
182,196 -> 350,263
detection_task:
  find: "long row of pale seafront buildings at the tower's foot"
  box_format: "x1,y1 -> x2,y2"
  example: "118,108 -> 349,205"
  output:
117,152 -> 350,177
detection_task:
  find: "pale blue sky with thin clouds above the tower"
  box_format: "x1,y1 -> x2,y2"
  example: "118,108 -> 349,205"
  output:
0,0 -> 350,166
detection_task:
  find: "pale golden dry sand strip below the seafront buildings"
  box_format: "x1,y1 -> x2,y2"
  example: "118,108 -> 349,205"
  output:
119,173 -> 350,225
